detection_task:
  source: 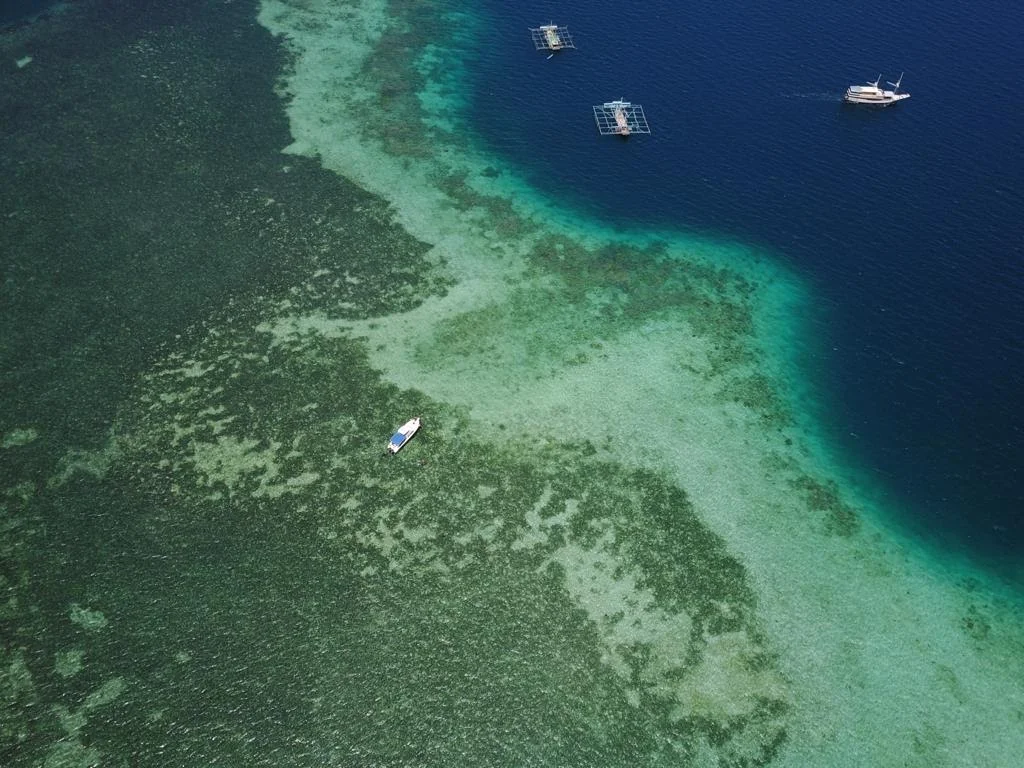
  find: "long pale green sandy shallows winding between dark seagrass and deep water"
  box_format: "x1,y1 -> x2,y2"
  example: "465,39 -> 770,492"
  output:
247,2 -> 1024,766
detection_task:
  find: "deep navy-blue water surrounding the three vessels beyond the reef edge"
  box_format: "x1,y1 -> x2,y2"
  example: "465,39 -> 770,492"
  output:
468,0 -> 1024,560
